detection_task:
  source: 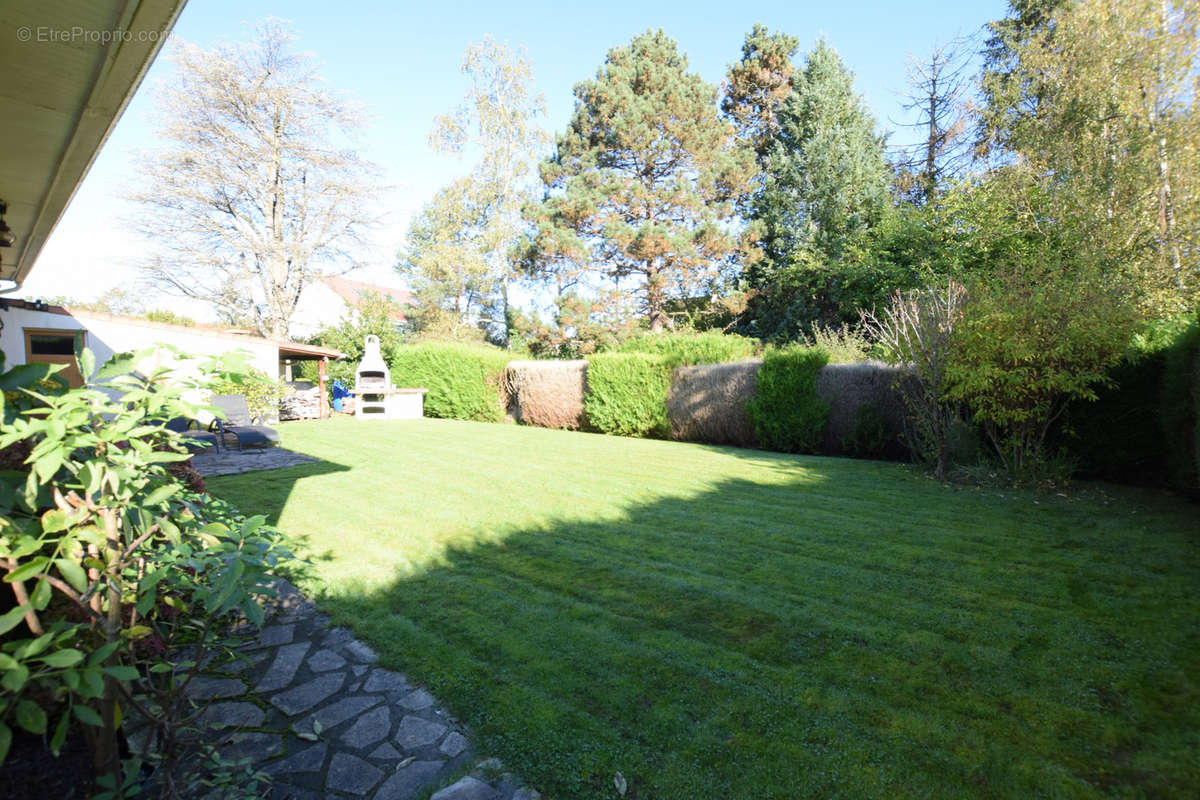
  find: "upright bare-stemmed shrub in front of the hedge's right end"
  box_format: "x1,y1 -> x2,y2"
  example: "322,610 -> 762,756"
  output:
858,281 -> 967,480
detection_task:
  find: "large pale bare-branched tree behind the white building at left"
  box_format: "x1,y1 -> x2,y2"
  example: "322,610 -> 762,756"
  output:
132,19 -> 379,337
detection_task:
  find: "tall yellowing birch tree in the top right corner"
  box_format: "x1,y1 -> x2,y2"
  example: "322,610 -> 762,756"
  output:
984,0 -> 1200,314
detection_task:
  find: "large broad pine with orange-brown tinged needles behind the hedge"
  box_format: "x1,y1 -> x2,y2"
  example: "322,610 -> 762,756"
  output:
527,31 -> 755,331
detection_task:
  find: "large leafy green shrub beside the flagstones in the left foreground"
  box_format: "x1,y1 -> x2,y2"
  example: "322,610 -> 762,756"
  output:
0,350 -> 290,796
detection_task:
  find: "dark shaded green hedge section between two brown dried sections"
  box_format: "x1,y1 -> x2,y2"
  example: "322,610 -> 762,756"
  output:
746,344 -> 829,453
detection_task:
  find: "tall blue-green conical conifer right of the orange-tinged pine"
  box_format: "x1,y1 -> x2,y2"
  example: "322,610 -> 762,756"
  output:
746,41 -> 892,338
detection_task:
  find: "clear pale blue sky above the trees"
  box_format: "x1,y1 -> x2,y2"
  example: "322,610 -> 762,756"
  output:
23,0 -> 1006,315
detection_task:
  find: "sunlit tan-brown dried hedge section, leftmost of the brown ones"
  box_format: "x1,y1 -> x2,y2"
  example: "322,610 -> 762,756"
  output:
504,361 -> 588,431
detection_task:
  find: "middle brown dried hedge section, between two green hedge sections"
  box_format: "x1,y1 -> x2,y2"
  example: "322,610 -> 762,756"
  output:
667,359 -> 762,447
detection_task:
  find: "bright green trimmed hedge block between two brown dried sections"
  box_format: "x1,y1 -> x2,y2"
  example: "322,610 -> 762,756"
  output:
583,353 -> 671,438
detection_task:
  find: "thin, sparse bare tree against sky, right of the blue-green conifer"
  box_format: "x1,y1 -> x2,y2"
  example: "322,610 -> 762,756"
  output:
896,37 -> 972,203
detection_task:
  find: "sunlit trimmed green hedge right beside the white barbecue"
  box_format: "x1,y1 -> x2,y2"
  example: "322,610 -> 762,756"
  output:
389,342 -> 511,422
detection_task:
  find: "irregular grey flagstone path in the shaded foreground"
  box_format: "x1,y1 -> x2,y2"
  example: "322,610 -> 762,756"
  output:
160,582 -> 539,800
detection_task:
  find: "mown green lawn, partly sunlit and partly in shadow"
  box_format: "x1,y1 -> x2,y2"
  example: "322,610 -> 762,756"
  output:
209,420 -> 1200,800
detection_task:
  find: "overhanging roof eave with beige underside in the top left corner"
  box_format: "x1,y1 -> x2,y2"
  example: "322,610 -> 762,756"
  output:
0,0 -> 184,283
